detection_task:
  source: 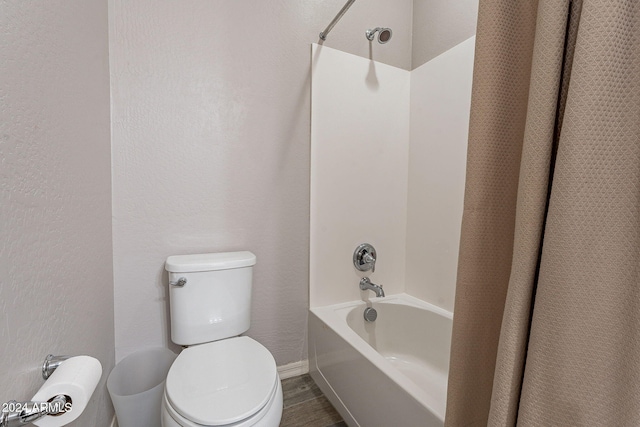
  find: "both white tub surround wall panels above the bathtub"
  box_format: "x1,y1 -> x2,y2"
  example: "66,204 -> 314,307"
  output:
310,37 -> 475,311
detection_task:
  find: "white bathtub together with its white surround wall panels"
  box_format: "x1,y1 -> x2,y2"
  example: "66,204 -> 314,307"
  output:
309,37 -> 475,427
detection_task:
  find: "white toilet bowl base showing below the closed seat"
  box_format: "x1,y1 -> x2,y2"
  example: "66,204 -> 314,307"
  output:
161,378 -> 283,427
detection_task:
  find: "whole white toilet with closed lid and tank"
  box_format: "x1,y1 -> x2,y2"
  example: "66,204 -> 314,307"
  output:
162,251 -> 282,427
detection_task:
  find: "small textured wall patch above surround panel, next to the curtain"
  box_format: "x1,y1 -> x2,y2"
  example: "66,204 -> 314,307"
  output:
411,0 -> 478,69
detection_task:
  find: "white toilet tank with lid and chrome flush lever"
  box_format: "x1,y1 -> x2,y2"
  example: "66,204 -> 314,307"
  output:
165,251 -> 256,345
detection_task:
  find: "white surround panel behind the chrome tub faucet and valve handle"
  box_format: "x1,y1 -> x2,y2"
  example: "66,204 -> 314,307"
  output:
310,45 -> 410,307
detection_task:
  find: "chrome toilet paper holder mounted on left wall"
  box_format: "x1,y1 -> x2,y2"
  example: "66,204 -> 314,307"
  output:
0,354 -> 72,427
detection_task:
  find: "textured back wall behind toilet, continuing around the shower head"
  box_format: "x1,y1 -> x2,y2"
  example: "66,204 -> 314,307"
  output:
109,0 -> 411,364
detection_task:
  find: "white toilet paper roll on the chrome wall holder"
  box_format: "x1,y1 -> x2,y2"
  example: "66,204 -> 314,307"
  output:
31,356 -> 102,427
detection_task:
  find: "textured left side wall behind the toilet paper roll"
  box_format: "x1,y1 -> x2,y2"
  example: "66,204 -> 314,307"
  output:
0,0 -> 114,426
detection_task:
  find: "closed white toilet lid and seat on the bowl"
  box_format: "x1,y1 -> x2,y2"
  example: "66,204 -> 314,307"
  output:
165,337 -> 280,426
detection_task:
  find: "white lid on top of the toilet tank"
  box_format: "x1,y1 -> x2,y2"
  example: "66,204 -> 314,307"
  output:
164,251 -> 256,273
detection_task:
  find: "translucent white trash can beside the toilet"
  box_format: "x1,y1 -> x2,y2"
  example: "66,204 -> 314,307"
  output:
107,348 -> 178,427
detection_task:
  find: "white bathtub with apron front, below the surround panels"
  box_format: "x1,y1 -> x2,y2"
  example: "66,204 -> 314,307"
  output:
309,294 -> 452,427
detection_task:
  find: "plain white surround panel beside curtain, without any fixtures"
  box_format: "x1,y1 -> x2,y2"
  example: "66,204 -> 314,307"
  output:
406,37 -> 475,311
